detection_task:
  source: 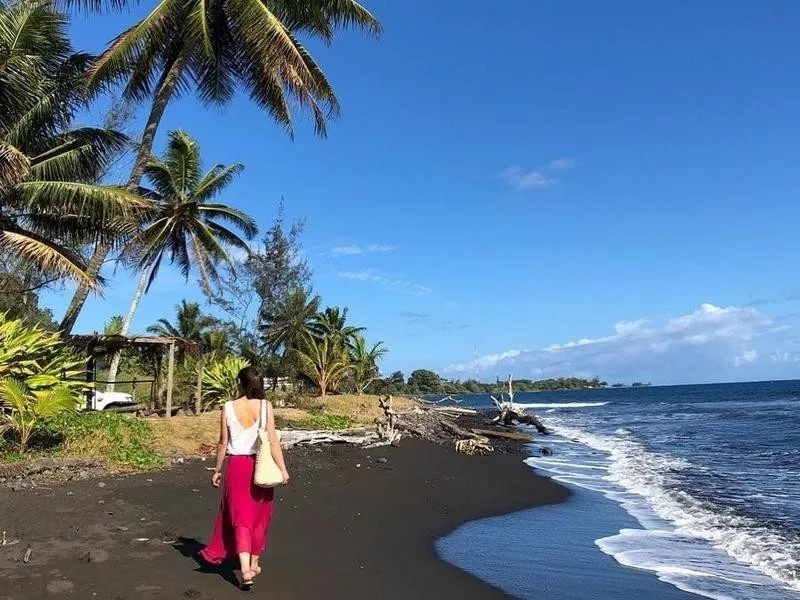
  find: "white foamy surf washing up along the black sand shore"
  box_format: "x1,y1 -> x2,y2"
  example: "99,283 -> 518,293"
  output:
527,418 -> 800,600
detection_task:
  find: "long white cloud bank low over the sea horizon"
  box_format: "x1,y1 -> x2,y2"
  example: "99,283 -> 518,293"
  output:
446,304 -> 791,382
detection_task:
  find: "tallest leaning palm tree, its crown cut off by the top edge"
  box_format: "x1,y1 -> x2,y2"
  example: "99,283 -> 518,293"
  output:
61,0 -> 381,332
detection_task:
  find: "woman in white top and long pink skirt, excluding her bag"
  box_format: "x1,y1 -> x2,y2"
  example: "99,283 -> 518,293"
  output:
200,367 -> 289,589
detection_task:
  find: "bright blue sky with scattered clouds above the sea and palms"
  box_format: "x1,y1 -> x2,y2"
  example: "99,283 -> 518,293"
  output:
39,0 -> 800,383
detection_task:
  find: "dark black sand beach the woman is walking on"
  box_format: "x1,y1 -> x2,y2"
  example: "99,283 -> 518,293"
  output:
0,440 -> 567,600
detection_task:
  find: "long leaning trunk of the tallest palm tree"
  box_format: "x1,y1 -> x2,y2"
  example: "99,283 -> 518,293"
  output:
59,57 -> 185,336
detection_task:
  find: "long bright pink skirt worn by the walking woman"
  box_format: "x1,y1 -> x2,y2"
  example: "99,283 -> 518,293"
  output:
200,456 -> 274,565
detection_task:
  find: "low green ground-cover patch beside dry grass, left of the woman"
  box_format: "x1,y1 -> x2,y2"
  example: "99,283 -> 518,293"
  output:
39,412 -> 164,471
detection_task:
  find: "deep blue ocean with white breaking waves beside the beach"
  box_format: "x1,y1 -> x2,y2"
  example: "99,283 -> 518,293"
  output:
444,381 -> 800,600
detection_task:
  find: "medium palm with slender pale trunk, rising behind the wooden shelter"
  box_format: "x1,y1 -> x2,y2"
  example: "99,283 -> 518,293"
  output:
108,131 -> 258,389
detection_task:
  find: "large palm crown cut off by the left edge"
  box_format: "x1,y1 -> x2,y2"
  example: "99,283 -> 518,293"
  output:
0,2 -> 147,289
